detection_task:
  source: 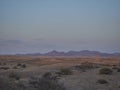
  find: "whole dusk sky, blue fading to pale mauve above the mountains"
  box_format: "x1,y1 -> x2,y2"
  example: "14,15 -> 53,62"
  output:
0,0 -> 120,54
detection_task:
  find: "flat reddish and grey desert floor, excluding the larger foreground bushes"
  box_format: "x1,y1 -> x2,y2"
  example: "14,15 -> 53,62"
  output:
0,56 -> 120,90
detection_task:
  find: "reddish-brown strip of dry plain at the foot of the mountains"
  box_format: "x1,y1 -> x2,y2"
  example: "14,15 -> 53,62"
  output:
0,55 -> 120,66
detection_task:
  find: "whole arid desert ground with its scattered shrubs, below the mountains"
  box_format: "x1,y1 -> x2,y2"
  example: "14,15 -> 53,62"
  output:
0,56 -> 120,90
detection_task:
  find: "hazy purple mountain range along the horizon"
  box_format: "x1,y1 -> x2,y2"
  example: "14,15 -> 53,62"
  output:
16,50 -> 120,57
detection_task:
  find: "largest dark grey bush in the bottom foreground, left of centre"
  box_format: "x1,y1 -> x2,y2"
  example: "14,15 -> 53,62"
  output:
29,73 -> 66,90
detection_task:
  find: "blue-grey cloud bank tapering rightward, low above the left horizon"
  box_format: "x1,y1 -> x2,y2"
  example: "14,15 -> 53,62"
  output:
0,39 -> 58,54
